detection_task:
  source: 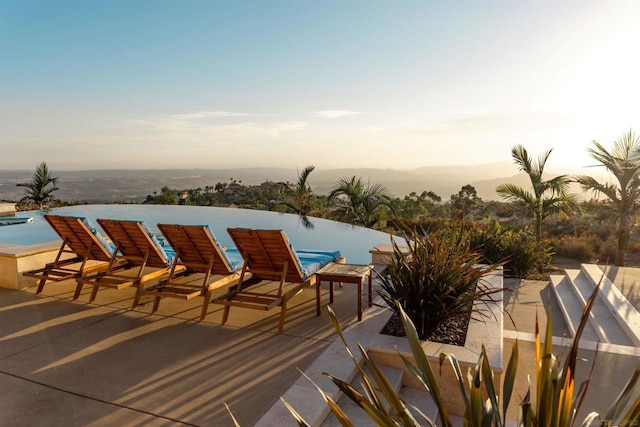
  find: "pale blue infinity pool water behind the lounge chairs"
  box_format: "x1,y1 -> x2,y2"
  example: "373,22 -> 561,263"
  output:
0,205 -> 398,264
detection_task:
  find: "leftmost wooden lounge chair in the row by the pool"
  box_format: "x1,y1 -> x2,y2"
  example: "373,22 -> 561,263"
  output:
22,215 -> 123,294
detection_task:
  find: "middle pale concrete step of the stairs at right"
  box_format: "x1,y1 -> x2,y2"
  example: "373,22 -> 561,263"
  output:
565,270 -> 633,346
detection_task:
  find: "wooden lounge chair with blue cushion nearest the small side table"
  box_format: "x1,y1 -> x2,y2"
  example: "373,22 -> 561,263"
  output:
213,228 -> 340,333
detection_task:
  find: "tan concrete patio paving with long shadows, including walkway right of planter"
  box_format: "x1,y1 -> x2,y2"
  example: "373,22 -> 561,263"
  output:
0,269 -> 640,426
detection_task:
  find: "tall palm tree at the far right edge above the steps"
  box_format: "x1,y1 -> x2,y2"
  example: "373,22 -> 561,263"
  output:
576,129 -> 640,266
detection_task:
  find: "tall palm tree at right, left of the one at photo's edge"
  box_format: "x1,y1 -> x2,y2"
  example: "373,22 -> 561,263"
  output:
496,144 -> 579,242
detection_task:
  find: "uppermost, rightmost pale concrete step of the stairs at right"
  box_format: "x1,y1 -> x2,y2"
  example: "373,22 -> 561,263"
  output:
580,264 -> 640,347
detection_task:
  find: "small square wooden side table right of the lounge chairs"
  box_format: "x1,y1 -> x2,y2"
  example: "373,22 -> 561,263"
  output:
316,262 -> 373,321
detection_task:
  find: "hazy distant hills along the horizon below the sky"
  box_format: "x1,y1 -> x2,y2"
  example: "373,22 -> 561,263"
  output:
0,162 -> 604,203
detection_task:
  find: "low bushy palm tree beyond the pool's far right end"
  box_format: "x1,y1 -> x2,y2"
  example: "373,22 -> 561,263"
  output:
329,176 -> 391,228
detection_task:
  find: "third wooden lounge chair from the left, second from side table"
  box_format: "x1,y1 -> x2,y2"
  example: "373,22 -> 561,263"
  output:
140,224 -> 242,320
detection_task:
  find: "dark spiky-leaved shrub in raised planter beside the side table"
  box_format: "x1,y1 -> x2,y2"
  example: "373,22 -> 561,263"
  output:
379,229 -> 501,337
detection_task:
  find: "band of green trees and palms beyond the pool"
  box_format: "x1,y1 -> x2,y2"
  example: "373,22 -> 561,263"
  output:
18,130 -> 640,266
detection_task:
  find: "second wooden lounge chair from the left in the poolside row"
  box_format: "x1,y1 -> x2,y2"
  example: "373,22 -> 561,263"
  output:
74,219 -> 184,309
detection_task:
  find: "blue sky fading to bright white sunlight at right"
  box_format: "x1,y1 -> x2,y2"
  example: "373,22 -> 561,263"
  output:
0,0 -> 640,171
